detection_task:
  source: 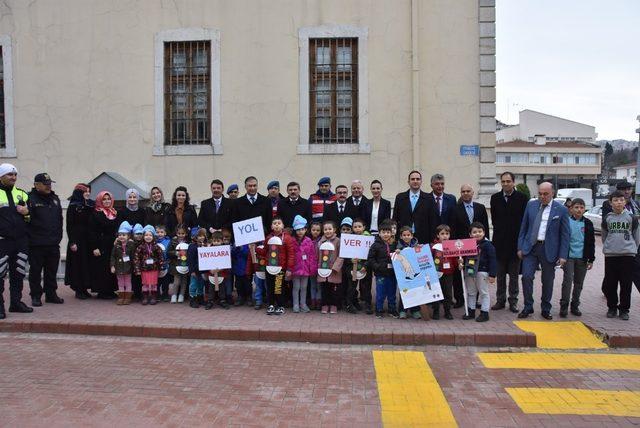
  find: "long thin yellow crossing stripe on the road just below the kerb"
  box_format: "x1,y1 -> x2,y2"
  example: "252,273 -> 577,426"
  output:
477,352 -> 640,371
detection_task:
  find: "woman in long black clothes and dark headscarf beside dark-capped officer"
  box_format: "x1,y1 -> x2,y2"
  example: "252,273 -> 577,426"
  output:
64,183 -> 95,300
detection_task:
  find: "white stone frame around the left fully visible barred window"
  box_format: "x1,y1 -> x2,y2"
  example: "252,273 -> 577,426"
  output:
153,28 -> 223,156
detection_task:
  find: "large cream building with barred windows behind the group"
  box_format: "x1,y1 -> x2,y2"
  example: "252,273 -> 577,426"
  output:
0,0 -> 496,207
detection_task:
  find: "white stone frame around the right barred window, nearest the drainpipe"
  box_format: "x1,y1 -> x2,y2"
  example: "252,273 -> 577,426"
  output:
297,25 -> 371,154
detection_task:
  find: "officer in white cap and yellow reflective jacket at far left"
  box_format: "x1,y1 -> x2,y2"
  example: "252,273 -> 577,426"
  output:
0,163 -> 33,319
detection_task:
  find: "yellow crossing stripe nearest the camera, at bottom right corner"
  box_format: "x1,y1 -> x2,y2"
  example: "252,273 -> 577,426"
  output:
506,388 -> 640,417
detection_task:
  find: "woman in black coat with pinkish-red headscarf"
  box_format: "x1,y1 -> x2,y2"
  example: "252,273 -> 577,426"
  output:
89,190 -> 120,299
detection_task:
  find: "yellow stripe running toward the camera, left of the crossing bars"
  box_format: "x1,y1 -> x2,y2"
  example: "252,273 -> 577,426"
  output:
373,351 -> 458,428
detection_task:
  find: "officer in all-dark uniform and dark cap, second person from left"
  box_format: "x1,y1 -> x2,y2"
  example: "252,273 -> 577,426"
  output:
27,173 -> 64,306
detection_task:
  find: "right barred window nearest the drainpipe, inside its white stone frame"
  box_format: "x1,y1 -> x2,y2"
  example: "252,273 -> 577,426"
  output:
309,38 -> 358,144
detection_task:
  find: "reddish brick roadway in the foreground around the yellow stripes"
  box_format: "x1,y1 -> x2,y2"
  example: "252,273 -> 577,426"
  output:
0,333 -> 640,427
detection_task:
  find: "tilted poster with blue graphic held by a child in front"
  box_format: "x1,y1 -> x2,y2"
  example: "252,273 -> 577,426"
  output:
391,245 -> 444,308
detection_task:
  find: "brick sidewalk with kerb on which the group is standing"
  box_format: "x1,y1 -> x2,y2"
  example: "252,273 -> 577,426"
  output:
0,242 -> 640,347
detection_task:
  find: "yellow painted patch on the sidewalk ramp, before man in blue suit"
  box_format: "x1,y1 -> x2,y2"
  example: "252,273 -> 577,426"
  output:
514,321 -> 607,349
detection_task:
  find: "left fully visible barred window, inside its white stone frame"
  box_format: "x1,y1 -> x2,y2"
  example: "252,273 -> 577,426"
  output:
164,40 -> 211,146
